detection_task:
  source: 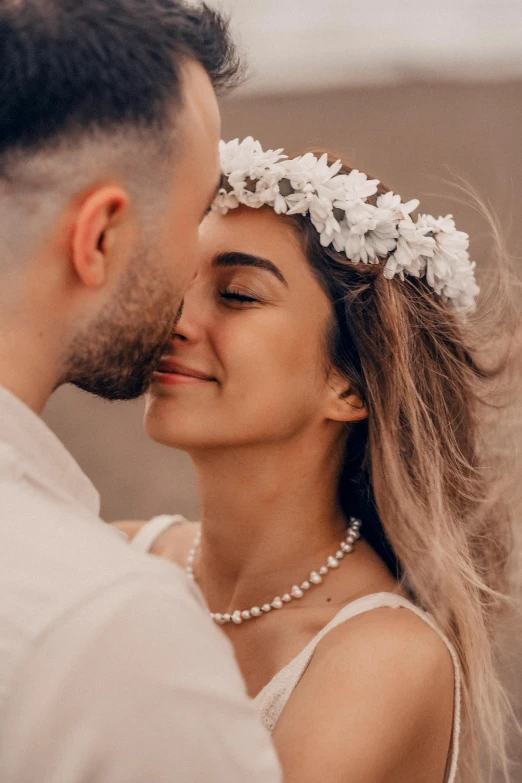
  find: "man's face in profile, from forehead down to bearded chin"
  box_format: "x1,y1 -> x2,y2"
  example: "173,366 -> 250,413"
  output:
63,61 -> 221,400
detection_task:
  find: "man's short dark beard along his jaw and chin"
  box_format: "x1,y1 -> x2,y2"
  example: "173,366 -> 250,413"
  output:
61,251 -> 181,400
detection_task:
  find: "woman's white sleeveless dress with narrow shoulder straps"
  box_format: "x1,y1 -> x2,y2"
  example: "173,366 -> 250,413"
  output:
131,514 -> 461,783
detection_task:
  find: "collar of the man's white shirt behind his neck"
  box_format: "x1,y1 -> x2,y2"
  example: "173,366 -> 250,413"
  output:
0,386 -> 100,516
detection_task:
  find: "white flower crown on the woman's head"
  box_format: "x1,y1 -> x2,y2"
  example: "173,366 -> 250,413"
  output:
213,136 -> 479,310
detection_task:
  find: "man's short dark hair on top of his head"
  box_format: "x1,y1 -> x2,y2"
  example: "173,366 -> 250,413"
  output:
0,0 -> 241,158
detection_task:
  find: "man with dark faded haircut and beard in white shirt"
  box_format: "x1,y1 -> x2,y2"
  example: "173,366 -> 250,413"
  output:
0,0 -> 279,783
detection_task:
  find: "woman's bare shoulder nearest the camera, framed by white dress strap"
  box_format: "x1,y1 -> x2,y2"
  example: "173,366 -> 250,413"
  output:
274,607 -> 455,783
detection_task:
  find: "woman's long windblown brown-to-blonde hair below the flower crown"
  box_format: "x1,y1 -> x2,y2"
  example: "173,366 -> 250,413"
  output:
285,158 -> 515,783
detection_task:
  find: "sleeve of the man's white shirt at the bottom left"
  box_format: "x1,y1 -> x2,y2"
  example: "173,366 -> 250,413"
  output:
0,568 -> 281,783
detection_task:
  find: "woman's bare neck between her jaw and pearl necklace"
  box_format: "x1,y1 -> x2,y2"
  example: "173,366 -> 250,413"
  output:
192,432 -> 346,612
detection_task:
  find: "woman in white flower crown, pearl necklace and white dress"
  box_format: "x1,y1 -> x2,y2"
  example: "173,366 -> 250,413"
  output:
114,139 -> 509,783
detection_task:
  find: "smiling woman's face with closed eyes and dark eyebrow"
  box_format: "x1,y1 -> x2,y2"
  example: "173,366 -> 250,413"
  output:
146,207 -> 344,452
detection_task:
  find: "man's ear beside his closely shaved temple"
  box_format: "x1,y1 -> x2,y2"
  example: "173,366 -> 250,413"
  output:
71,185 -> 128,288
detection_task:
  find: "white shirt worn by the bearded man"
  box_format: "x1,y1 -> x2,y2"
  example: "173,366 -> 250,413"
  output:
0,387 -> 280,783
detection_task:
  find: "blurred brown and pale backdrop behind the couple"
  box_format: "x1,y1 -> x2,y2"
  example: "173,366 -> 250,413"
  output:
41,0 -> 522,780
